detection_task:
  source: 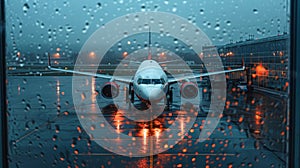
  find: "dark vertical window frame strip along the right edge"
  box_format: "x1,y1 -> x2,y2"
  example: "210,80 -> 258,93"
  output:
288,0 -> 300,167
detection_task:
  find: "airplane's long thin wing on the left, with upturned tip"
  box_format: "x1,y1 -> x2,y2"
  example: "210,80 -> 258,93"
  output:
48,56 -> 132,83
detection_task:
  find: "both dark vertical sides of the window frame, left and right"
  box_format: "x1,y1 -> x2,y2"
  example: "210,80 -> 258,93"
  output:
0,0 -> 300,167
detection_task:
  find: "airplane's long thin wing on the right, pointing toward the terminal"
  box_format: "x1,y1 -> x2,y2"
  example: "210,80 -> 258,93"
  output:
168,65 -> 245,84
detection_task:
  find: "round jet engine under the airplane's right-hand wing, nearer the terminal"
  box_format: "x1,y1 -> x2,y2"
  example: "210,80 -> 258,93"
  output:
180,82 -> 198,99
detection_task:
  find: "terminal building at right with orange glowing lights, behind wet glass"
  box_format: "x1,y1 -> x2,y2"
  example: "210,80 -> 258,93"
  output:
203,35 -> 289,94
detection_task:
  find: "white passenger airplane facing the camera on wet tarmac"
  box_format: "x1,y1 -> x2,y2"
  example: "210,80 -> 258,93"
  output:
48,31 -> 245,105
